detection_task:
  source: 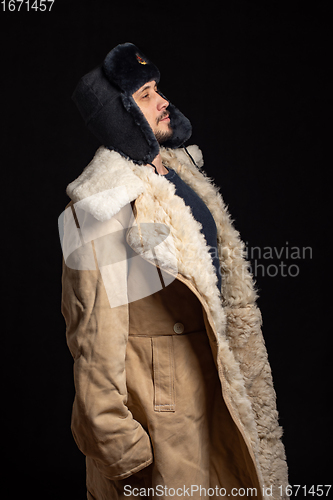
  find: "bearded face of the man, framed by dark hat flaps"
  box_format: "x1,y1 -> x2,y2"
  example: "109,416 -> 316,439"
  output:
133,81 -> 172,144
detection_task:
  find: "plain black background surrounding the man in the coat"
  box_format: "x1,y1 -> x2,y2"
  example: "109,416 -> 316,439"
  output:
0,0 -> 332,500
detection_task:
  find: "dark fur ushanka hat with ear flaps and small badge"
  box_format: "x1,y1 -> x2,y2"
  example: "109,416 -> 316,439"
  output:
72,43 -> 192,164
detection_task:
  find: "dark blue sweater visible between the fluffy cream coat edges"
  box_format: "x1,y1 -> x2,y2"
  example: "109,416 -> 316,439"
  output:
164,169 -> 221,290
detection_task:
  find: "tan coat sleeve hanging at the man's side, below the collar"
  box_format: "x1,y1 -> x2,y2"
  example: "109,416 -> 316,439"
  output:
62,202 -> 153,479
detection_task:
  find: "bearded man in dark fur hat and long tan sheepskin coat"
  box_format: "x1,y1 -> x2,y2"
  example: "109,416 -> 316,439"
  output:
62,44 -> 288,500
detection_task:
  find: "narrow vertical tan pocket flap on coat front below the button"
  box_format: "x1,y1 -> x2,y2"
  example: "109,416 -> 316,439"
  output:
151,336 -> 176,411
